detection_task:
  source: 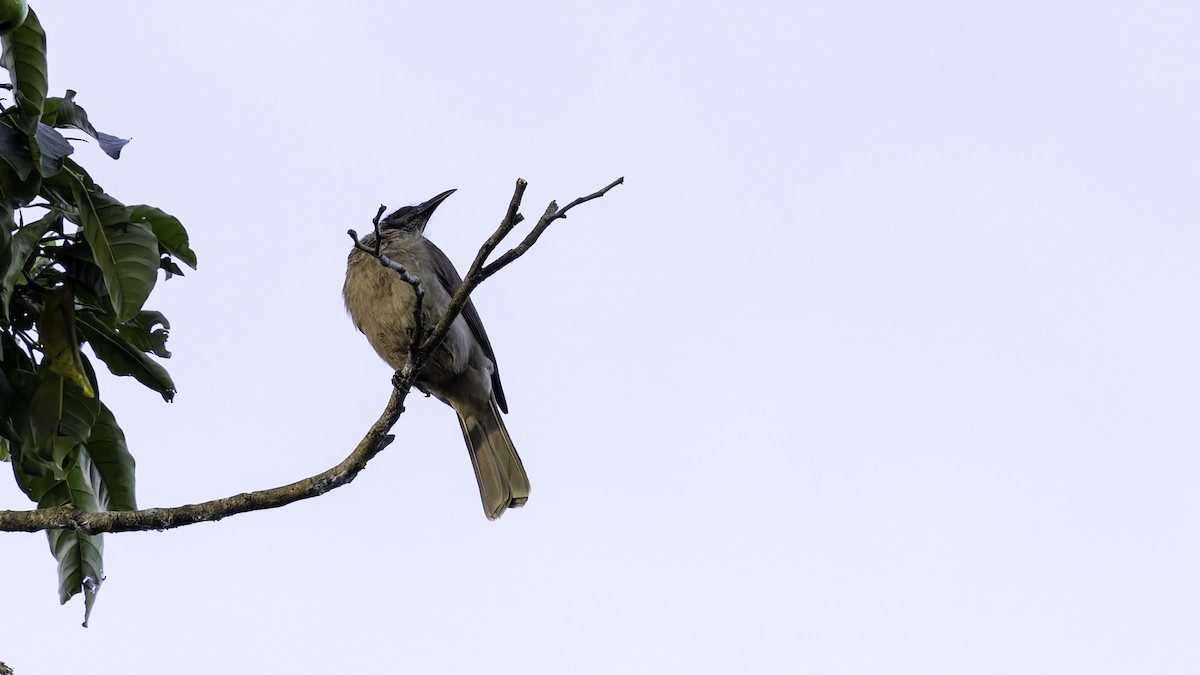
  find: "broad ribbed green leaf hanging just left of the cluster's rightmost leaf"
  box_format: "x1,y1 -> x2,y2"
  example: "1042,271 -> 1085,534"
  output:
74,184 -> 158,323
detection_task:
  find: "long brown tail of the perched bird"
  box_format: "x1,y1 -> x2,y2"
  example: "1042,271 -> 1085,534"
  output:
458,402 -> 529,520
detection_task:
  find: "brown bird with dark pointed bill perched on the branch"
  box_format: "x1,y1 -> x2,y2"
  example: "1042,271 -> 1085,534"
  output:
342,190 -> 529,520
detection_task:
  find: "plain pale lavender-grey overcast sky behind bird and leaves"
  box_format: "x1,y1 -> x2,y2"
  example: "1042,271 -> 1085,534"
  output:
0,0 -> 1200,675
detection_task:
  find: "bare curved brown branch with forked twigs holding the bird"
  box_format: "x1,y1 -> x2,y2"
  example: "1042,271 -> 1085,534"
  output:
0,178 -> 625,534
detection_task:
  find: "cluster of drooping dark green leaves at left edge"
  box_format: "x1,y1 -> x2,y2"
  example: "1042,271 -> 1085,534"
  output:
0,10 -> 196,625
